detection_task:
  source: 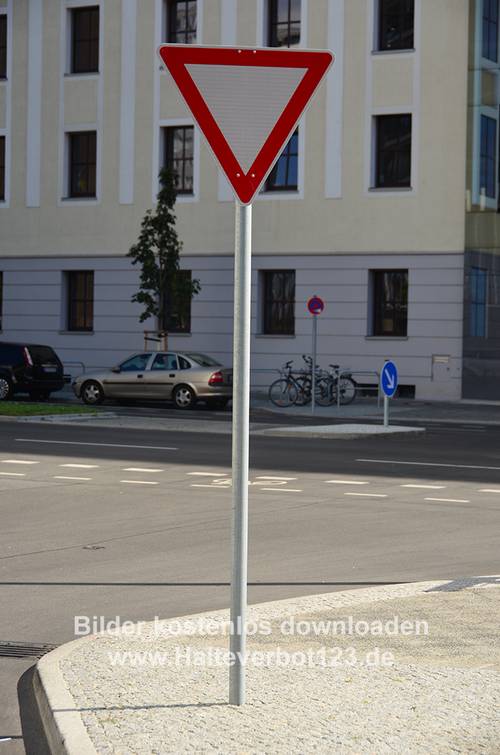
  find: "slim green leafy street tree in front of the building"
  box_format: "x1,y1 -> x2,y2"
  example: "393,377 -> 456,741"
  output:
128,168 -> 200,349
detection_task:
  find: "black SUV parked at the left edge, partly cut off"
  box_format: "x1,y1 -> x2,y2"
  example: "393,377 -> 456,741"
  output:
0,341 -> 64,401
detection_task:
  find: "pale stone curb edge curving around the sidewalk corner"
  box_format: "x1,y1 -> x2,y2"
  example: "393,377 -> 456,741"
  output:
33,577 -> 492,755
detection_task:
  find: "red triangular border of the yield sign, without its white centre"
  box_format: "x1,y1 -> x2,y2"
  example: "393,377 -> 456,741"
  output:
158,45 -> 334,204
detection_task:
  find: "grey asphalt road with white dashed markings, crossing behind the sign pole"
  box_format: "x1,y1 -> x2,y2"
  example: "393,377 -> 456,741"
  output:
0,422 -> 500,755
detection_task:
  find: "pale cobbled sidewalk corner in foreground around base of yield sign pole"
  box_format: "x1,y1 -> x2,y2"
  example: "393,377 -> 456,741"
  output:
37,577 -> 500,755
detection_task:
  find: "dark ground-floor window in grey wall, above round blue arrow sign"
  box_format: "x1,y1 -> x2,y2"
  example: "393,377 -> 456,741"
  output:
371,270 -> 408,336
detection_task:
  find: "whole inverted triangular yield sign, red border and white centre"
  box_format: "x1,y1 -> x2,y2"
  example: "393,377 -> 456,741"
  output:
158,45 -> 333,204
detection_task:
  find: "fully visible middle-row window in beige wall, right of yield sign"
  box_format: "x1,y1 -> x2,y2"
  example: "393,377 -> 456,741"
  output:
375,115 -> 411,189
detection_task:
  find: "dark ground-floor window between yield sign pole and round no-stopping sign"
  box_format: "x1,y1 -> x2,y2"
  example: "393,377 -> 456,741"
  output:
262,270 -> 295,336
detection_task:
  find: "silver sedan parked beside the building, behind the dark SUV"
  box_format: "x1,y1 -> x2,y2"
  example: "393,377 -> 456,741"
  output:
72,351 -> 233,409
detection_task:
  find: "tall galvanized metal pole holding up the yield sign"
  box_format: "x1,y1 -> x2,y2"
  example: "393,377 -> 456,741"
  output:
229,202 -> 252,705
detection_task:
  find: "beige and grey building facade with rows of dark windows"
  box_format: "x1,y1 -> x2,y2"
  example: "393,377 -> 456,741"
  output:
0,0 -> 484,399
